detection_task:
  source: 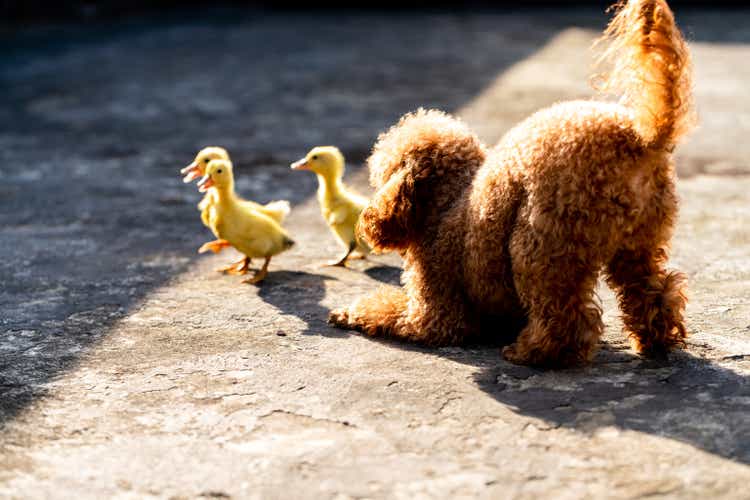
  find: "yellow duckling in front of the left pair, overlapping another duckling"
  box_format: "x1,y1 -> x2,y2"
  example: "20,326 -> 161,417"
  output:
198,160 -> 294,284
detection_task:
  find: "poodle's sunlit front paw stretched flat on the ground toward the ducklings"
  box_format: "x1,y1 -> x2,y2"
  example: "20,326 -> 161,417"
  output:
328,286 -> 414,338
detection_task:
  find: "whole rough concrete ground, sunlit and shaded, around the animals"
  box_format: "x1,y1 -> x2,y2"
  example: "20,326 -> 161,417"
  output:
0,7 -> 750,498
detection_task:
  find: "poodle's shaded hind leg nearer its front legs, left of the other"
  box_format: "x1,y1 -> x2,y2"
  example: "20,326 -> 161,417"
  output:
503,252 -> 604,368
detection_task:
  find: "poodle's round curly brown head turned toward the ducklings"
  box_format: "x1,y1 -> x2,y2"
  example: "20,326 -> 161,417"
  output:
358,109 -> 486,251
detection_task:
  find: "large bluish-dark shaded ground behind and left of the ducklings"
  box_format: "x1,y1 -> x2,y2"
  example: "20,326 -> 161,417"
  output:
0,10 -> 559,422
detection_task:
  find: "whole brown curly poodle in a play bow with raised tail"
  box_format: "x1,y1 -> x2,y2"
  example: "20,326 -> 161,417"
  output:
330,0 -> 692,366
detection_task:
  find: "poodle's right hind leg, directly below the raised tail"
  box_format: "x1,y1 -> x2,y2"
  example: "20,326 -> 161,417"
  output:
607,247 -> 687,359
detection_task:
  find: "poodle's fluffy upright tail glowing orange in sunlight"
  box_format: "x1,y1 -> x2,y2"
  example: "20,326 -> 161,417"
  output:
597,0 -> 695,149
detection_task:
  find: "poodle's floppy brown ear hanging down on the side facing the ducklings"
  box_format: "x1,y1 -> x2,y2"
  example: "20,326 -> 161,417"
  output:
357,168 -> 417,253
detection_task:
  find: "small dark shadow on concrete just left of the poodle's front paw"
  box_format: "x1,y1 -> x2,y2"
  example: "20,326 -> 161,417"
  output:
258,271 -> 349,337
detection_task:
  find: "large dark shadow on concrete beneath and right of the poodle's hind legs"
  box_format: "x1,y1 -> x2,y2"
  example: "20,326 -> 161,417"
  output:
436,339 -> 750,464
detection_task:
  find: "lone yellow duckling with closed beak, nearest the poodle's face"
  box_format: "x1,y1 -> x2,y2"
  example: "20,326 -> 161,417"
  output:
291,146 -> 370,266
